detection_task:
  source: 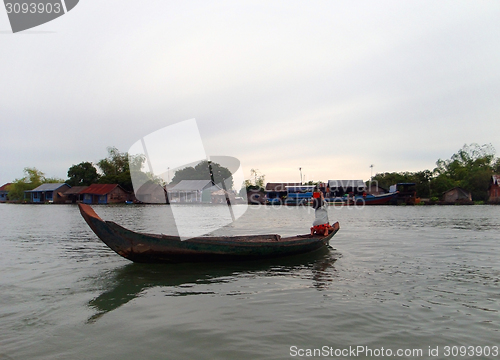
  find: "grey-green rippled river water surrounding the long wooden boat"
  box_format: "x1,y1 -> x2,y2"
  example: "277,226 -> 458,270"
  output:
0,204 -> 500,360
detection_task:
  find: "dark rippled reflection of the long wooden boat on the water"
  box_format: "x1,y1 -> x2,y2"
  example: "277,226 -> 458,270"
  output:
88,247 -> 340,322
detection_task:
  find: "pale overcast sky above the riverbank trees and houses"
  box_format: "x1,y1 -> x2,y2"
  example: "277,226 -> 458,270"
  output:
0,0 -> 500,186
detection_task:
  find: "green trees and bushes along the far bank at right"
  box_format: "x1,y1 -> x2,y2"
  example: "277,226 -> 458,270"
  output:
372,143 -> 500,201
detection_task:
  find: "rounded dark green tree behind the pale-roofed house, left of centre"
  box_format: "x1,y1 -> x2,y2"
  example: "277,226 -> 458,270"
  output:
172,160 -> 233,190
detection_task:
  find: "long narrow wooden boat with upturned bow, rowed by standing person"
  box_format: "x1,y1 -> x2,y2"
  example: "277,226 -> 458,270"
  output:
78,204 -> 339,263
